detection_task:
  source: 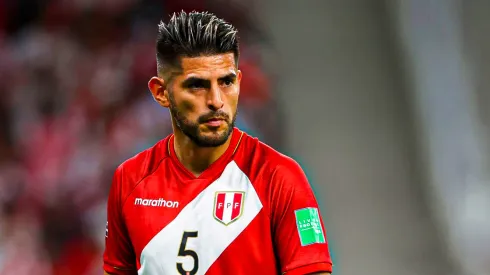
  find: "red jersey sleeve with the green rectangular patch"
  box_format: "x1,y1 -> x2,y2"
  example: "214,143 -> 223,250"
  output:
270,159 -> 332,275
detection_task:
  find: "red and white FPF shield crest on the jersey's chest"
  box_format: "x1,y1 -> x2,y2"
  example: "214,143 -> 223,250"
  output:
213,191 -> 245,225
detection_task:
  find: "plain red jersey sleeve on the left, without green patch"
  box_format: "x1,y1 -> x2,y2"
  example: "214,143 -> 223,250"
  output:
104,167 -> 136,275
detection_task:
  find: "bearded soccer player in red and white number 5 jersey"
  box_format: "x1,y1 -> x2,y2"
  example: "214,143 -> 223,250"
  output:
104,12 -> 332,275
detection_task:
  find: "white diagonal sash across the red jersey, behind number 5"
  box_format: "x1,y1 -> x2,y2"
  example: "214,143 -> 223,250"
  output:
138,161 -> 262,275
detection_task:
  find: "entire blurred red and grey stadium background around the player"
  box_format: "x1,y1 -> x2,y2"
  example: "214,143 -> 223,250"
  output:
0,0 -> 490,275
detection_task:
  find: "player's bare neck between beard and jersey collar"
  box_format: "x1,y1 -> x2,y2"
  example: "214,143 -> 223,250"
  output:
174,130 -> 232,177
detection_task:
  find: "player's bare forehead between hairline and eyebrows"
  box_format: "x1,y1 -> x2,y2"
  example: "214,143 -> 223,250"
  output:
181,53 -> 236,79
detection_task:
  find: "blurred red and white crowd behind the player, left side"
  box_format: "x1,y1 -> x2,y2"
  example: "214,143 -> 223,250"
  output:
0,0 -> 282,275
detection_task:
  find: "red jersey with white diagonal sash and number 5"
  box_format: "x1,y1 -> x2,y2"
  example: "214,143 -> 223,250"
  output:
104,128 -> 332,275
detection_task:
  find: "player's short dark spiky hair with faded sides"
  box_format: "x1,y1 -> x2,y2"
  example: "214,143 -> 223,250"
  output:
156,11 -> 240,74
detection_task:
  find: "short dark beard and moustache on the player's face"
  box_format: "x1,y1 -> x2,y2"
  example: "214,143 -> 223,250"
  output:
169,92 -> 237,147
